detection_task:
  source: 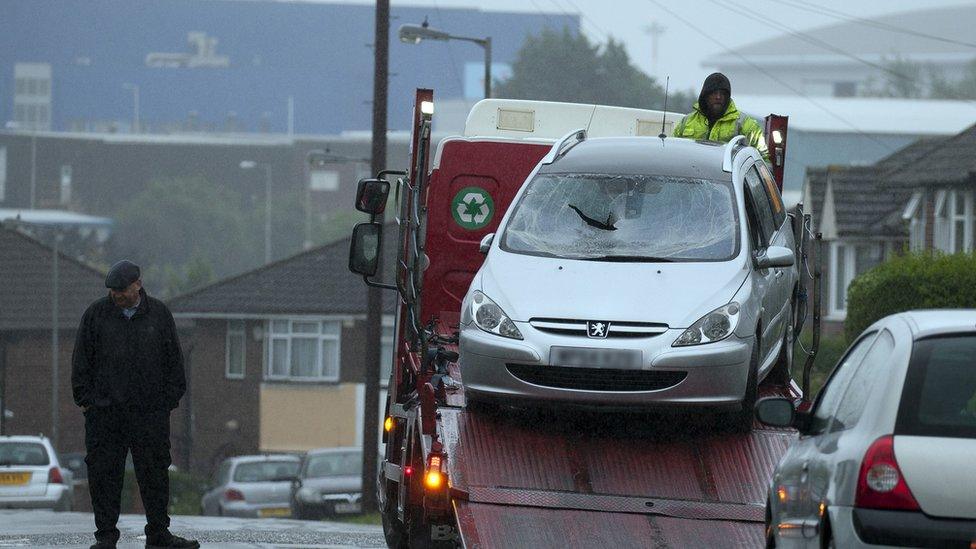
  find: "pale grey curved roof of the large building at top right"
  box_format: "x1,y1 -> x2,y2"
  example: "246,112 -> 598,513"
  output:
703,5 -> 976,65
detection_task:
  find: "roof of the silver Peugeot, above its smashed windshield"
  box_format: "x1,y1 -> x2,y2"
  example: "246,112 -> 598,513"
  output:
539,137 -> 730,180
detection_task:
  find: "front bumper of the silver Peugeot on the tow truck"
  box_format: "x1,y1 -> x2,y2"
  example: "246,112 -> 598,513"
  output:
460,322 -> 754,408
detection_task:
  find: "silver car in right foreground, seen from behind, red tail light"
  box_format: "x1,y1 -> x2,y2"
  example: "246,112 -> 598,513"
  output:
757,310 -> 976,548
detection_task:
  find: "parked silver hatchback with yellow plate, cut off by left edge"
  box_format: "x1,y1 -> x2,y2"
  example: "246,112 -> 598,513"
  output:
0,436 -> 74,511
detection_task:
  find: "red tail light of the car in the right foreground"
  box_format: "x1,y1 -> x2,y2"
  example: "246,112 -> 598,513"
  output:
854,435 -> 920,511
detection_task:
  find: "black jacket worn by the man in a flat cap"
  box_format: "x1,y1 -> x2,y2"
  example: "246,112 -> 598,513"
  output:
71,290 -> 186,410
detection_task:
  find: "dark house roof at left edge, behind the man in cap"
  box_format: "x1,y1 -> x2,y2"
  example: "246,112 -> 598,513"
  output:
0,228 -> 106,330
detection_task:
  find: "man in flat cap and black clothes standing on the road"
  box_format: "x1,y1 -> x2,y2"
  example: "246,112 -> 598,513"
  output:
71,260 -> 200,549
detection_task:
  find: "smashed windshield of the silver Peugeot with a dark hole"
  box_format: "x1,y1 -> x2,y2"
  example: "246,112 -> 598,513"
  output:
501,174 -> 739,261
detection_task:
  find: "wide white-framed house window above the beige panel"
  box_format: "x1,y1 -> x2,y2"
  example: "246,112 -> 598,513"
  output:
267,320 -> 342,381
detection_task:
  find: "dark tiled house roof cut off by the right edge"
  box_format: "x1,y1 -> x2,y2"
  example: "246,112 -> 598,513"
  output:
893,125 -> 976,187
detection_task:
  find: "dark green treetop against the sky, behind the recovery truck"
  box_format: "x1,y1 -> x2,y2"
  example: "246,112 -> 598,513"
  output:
495,28 -> 695,112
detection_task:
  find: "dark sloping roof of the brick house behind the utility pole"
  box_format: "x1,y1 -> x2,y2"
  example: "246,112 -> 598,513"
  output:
169,224 -> 396,317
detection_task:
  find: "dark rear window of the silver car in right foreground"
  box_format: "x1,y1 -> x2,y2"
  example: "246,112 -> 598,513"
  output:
895,334 -> 976,438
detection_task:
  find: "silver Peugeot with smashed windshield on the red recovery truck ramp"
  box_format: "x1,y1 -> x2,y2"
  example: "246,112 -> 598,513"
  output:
460,137 -> 798,428
